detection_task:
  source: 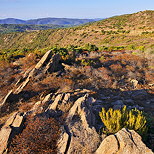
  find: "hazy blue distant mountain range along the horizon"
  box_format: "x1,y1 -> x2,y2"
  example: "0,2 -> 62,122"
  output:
0,18 -> 101,26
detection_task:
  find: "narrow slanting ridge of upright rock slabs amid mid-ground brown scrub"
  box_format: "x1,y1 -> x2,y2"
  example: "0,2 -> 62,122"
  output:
0,50 -> 60,108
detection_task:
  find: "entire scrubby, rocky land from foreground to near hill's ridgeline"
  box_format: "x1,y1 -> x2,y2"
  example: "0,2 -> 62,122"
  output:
0,11 -> 154,154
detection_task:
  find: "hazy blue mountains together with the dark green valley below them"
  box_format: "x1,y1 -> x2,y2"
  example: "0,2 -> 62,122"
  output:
0,18 -> 100,33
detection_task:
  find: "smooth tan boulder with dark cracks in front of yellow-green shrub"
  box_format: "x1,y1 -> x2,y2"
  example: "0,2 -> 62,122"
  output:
95,128 -> 153,154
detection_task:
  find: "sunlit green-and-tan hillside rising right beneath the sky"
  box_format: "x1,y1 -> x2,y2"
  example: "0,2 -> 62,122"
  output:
0,11 -> 154,49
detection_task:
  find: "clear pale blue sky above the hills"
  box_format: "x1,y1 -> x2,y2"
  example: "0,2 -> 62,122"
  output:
0,0 -> 154,19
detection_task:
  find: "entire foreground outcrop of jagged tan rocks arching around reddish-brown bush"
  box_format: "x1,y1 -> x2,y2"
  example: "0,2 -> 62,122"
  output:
0,89 -> 152,154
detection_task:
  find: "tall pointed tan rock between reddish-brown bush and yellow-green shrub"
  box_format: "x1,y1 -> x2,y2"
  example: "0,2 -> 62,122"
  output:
58,95 -> 100,154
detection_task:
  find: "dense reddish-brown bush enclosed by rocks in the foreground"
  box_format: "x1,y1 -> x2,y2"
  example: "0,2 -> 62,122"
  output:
9,117 -> 60,154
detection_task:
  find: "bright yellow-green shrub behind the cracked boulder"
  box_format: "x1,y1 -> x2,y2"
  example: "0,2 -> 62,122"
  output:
99,106 -> 148,135
